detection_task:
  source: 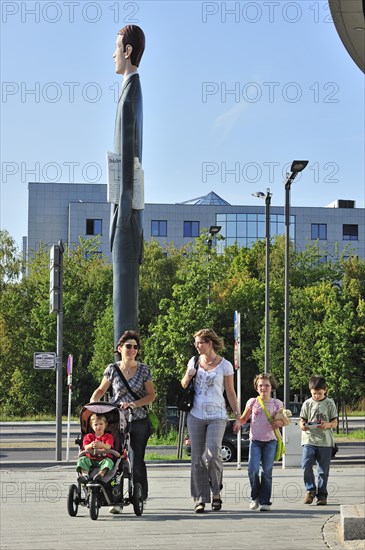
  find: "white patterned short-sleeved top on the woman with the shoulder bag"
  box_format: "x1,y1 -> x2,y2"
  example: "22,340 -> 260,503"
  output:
188,357 -> 233,420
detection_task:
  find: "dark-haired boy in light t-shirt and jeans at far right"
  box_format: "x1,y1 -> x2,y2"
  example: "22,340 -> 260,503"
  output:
300,376 -> 338,506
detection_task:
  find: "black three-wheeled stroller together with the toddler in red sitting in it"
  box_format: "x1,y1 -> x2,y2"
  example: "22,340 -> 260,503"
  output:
67,401 -> 144,520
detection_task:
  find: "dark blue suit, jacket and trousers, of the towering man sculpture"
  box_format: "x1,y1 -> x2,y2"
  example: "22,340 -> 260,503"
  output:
110,73 -> 143,341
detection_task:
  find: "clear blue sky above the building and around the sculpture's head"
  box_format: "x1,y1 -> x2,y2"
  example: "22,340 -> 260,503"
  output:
0,0 -> 365,248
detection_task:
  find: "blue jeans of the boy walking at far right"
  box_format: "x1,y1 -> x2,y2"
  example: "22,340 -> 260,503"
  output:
302,445 -> 332,498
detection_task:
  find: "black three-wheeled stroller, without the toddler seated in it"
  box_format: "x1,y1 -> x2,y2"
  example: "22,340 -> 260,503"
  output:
67,401 -> 144,520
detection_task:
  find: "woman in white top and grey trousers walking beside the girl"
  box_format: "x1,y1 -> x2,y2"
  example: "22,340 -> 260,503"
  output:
181,328 -> 239,513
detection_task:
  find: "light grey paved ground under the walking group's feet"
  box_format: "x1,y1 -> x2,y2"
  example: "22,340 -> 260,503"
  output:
0,464 -> 365,550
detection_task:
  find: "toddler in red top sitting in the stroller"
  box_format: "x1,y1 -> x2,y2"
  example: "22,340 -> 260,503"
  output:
76,413 -> 114,483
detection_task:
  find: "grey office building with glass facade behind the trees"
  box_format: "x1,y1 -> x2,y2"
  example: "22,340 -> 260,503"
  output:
27,182 -> 365,259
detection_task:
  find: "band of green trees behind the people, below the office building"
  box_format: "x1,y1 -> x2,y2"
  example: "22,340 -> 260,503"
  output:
0,231 -> 365,424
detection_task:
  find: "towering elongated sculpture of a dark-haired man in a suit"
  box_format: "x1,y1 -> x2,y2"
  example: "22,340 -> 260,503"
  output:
110,25 -> 145,343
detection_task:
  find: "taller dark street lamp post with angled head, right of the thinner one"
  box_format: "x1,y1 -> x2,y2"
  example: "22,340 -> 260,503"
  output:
284,160 -> 308,409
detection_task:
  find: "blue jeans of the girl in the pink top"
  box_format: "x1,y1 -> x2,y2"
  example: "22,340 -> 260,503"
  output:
248,439 -> 277,505
